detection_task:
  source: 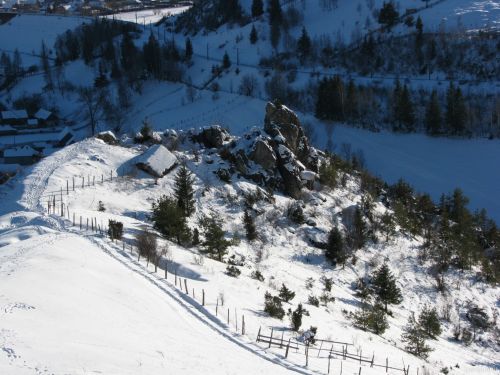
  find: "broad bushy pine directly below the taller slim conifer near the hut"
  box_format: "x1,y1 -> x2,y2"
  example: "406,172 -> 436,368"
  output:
151,195 -> 191,245
